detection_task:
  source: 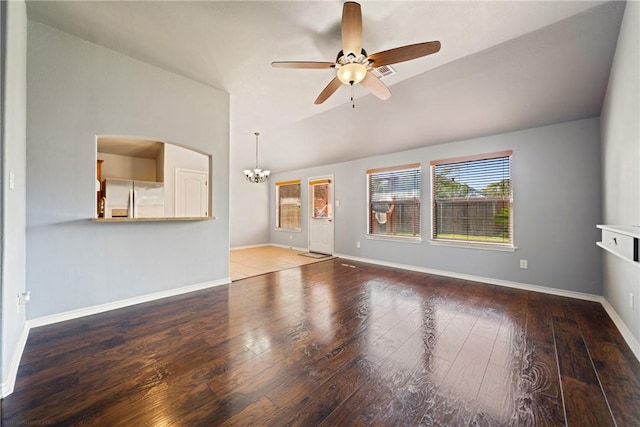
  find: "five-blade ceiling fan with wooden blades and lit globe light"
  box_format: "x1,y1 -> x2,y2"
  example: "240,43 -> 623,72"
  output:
271,1 -> 440,104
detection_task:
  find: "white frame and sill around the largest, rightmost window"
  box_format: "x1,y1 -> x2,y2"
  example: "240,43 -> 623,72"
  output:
429,150 -> 517,251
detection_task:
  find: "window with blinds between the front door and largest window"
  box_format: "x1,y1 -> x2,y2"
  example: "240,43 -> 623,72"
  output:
367,163 -> 421,239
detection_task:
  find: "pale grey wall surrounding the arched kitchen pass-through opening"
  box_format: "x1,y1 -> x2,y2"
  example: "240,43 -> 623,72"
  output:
26,21 -> 229,319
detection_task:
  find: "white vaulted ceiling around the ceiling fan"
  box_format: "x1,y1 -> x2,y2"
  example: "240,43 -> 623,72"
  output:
27,0 -> 625,172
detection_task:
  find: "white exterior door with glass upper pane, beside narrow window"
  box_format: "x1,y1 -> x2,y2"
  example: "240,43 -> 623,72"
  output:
309,176 -> 333,255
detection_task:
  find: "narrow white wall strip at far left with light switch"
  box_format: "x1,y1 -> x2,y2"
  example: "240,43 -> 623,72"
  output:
0,1 -> 27,396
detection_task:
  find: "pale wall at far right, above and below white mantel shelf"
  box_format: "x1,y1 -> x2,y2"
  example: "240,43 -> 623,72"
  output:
601,1 -> 640,341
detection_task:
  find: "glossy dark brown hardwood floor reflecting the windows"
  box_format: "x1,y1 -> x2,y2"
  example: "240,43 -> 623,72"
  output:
2,259 -> 640,426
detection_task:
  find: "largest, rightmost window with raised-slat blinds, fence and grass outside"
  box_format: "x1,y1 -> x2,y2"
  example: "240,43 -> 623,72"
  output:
431,151 -> 513,246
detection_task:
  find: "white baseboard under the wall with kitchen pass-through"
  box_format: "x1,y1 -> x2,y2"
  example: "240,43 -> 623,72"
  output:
27,277 -> 231,328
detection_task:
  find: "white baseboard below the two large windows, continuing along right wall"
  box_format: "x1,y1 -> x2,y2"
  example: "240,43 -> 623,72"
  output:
335,254 -> 640,362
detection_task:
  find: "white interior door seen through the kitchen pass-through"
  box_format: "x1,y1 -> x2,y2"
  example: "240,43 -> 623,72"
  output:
176,169 -> 209,217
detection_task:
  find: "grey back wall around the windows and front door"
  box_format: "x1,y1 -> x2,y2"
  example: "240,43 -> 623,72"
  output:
269,118 -> 602,295
